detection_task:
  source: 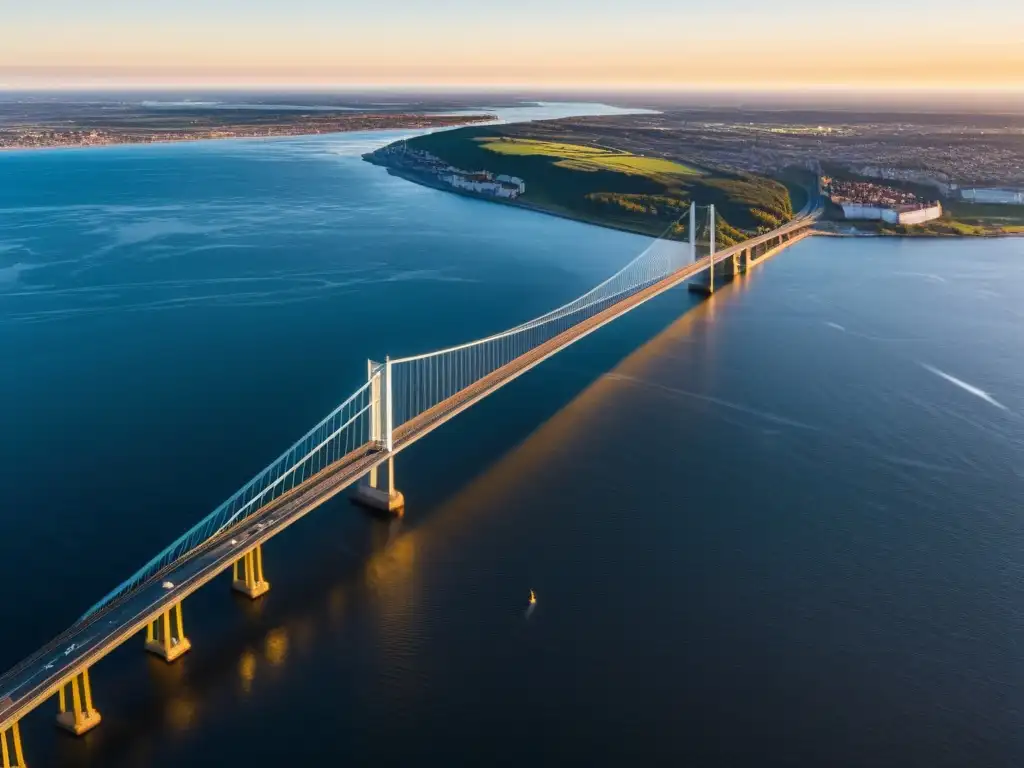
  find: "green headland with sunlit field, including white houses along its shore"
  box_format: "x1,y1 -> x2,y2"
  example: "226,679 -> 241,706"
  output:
364,121 -> 794,245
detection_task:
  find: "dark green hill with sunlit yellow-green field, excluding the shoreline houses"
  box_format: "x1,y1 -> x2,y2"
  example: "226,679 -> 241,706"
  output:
395,126 -> 793,245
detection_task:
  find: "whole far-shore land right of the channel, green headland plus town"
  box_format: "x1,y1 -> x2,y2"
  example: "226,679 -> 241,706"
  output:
364,103 -> 1024,237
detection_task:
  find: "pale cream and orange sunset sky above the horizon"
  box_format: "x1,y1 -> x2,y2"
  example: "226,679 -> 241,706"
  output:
0,0 -> 1024,90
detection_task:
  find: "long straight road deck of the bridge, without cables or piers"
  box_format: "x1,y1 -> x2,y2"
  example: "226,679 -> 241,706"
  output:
0,210 -> 816,733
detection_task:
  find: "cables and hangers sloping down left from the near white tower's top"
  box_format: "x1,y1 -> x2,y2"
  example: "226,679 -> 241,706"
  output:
82,366 -> 382,618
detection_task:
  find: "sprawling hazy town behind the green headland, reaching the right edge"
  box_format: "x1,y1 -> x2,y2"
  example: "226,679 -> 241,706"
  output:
513,108 -> 1024,205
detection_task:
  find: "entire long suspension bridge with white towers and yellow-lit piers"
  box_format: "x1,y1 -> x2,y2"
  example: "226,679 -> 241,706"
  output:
0,203 -> 819,768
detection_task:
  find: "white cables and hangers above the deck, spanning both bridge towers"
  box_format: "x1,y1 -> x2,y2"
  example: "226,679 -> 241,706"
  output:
82,202 -> 815,618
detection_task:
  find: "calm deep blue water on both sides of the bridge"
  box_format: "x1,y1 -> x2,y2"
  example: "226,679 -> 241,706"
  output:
0,117 -> 1024,767
